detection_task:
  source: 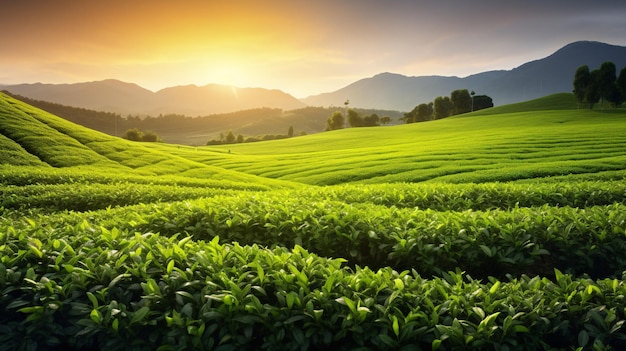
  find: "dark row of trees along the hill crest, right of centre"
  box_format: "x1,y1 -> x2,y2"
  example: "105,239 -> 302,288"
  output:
403,89 -> 493,123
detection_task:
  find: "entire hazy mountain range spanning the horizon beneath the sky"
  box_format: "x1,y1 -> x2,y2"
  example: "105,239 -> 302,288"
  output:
0,41 -> 626,116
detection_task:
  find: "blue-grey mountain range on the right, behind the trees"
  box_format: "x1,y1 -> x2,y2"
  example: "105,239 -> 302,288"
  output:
302,41 -> 626,111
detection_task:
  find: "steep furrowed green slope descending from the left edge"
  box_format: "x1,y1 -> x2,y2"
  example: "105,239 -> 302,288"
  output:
0,93 -> 294,187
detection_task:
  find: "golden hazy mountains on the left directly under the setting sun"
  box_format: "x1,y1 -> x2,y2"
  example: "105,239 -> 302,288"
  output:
0,79 -> 305,116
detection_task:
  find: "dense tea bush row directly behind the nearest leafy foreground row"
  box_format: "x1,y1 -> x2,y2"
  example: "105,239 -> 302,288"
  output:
9,192 -> 626,278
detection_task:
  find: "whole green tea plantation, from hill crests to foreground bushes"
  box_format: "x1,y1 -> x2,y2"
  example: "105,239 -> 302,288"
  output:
0,93 -> 626,351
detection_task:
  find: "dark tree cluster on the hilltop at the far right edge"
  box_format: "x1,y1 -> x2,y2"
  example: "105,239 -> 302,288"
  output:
574,61 -> 626,109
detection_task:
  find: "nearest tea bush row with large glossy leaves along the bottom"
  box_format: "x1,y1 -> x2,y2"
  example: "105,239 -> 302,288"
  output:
0,221 -> 626,351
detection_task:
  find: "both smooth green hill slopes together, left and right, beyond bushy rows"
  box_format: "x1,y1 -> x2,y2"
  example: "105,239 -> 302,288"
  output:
0,90 -> 626,185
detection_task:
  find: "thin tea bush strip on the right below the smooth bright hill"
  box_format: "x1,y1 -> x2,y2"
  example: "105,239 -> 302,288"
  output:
294,181 -> 626,211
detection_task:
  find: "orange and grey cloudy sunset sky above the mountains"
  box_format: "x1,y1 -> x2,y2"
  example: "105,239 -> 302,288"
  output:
0,0 -> 626,98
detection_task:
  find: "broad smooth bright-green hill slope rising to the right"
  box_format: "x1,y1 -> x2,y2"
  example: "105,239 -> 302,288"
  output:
146,94 -> 626,185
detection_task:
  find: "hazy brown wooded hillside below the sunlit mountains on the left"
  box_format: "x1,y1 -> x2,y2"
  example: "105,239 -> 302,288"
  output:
2,92 -> 403,145
